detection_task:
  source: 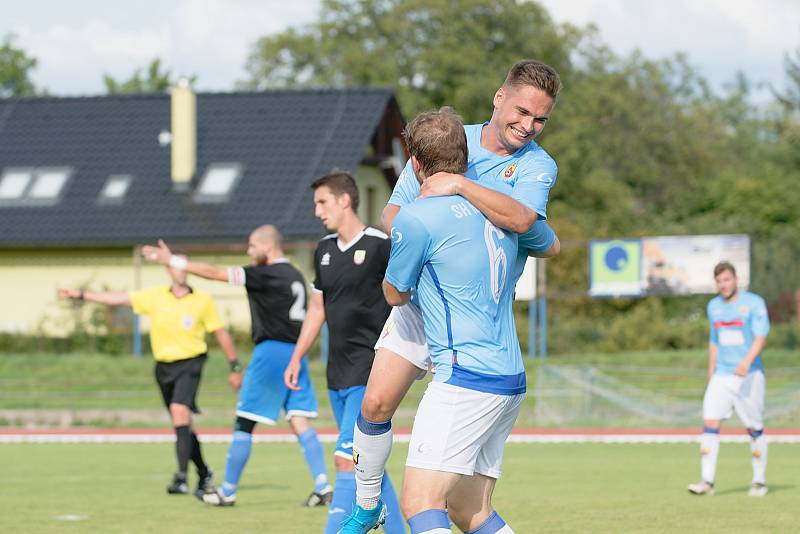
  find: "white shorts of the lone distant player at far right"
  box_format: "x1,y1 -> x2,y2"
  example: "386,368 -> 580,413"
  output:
703,371 -> 765,430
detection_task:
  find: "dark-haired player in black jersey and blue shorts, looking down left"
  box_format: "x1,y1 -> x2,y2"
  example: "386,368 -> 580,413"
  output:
284,171 -> 405,534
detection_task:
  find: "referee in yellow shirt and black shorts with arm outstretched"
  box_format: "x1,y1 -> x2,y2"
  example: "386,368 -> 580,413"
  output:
58,254 -> 242,499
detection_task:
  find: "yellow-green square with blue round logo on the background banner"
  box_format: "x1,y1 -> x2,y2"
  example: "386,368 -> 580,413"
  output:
589,240 -> 642,296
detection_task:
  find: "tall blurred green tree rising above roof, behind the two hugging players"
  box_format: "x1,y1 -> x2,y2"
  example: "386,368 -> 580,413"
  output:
240,0 -> 580,121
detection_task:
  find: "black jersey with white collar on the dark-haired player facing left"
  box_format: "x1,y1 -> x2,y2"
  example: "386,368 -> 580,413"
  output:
314,227 -> 392,389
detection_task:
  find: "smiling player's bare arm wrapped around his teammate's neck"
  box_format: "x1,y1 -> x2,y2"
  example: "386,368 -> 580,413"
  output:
420,172 -> 538,234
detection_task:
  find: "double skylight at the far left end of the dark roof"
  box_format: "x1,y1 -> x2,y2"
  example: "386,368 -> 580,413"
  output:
0,167 -> 72,206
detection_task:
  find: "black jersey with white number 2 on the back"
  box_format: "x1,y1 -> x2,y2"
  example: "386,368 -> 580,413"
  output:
238,259 -> 307,343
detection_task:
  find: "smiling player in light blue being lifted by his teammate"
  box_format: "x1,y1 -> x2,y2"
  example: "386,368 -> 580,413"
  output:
346,60 -> 561,532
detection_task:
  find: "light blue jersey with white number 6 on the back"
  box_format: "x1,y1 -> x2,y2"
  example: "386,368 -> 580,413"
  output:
386,184 -> 525,395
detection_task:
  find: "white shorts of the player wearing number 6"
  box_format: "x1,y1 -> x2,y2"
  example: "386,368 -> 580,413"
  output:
406,382 -> 525,478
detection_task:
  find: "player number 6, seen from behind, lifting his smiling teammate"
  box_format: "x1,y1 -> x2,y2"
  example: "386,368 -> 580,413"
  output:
384,108 -> 526,534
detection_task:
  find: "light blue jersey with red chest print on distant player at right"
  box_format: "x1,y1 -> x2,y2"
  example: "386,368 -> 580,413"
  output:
708,291 -> 769,375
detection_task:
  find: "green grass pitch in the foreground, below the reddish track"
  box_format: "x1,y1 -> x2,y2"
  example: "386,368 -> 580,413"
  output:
6,443 -> 800,534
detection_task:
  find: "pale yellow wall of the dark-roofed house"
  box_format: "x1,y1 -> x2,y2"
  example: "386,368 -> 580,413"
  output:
0,166 -> 391,335
